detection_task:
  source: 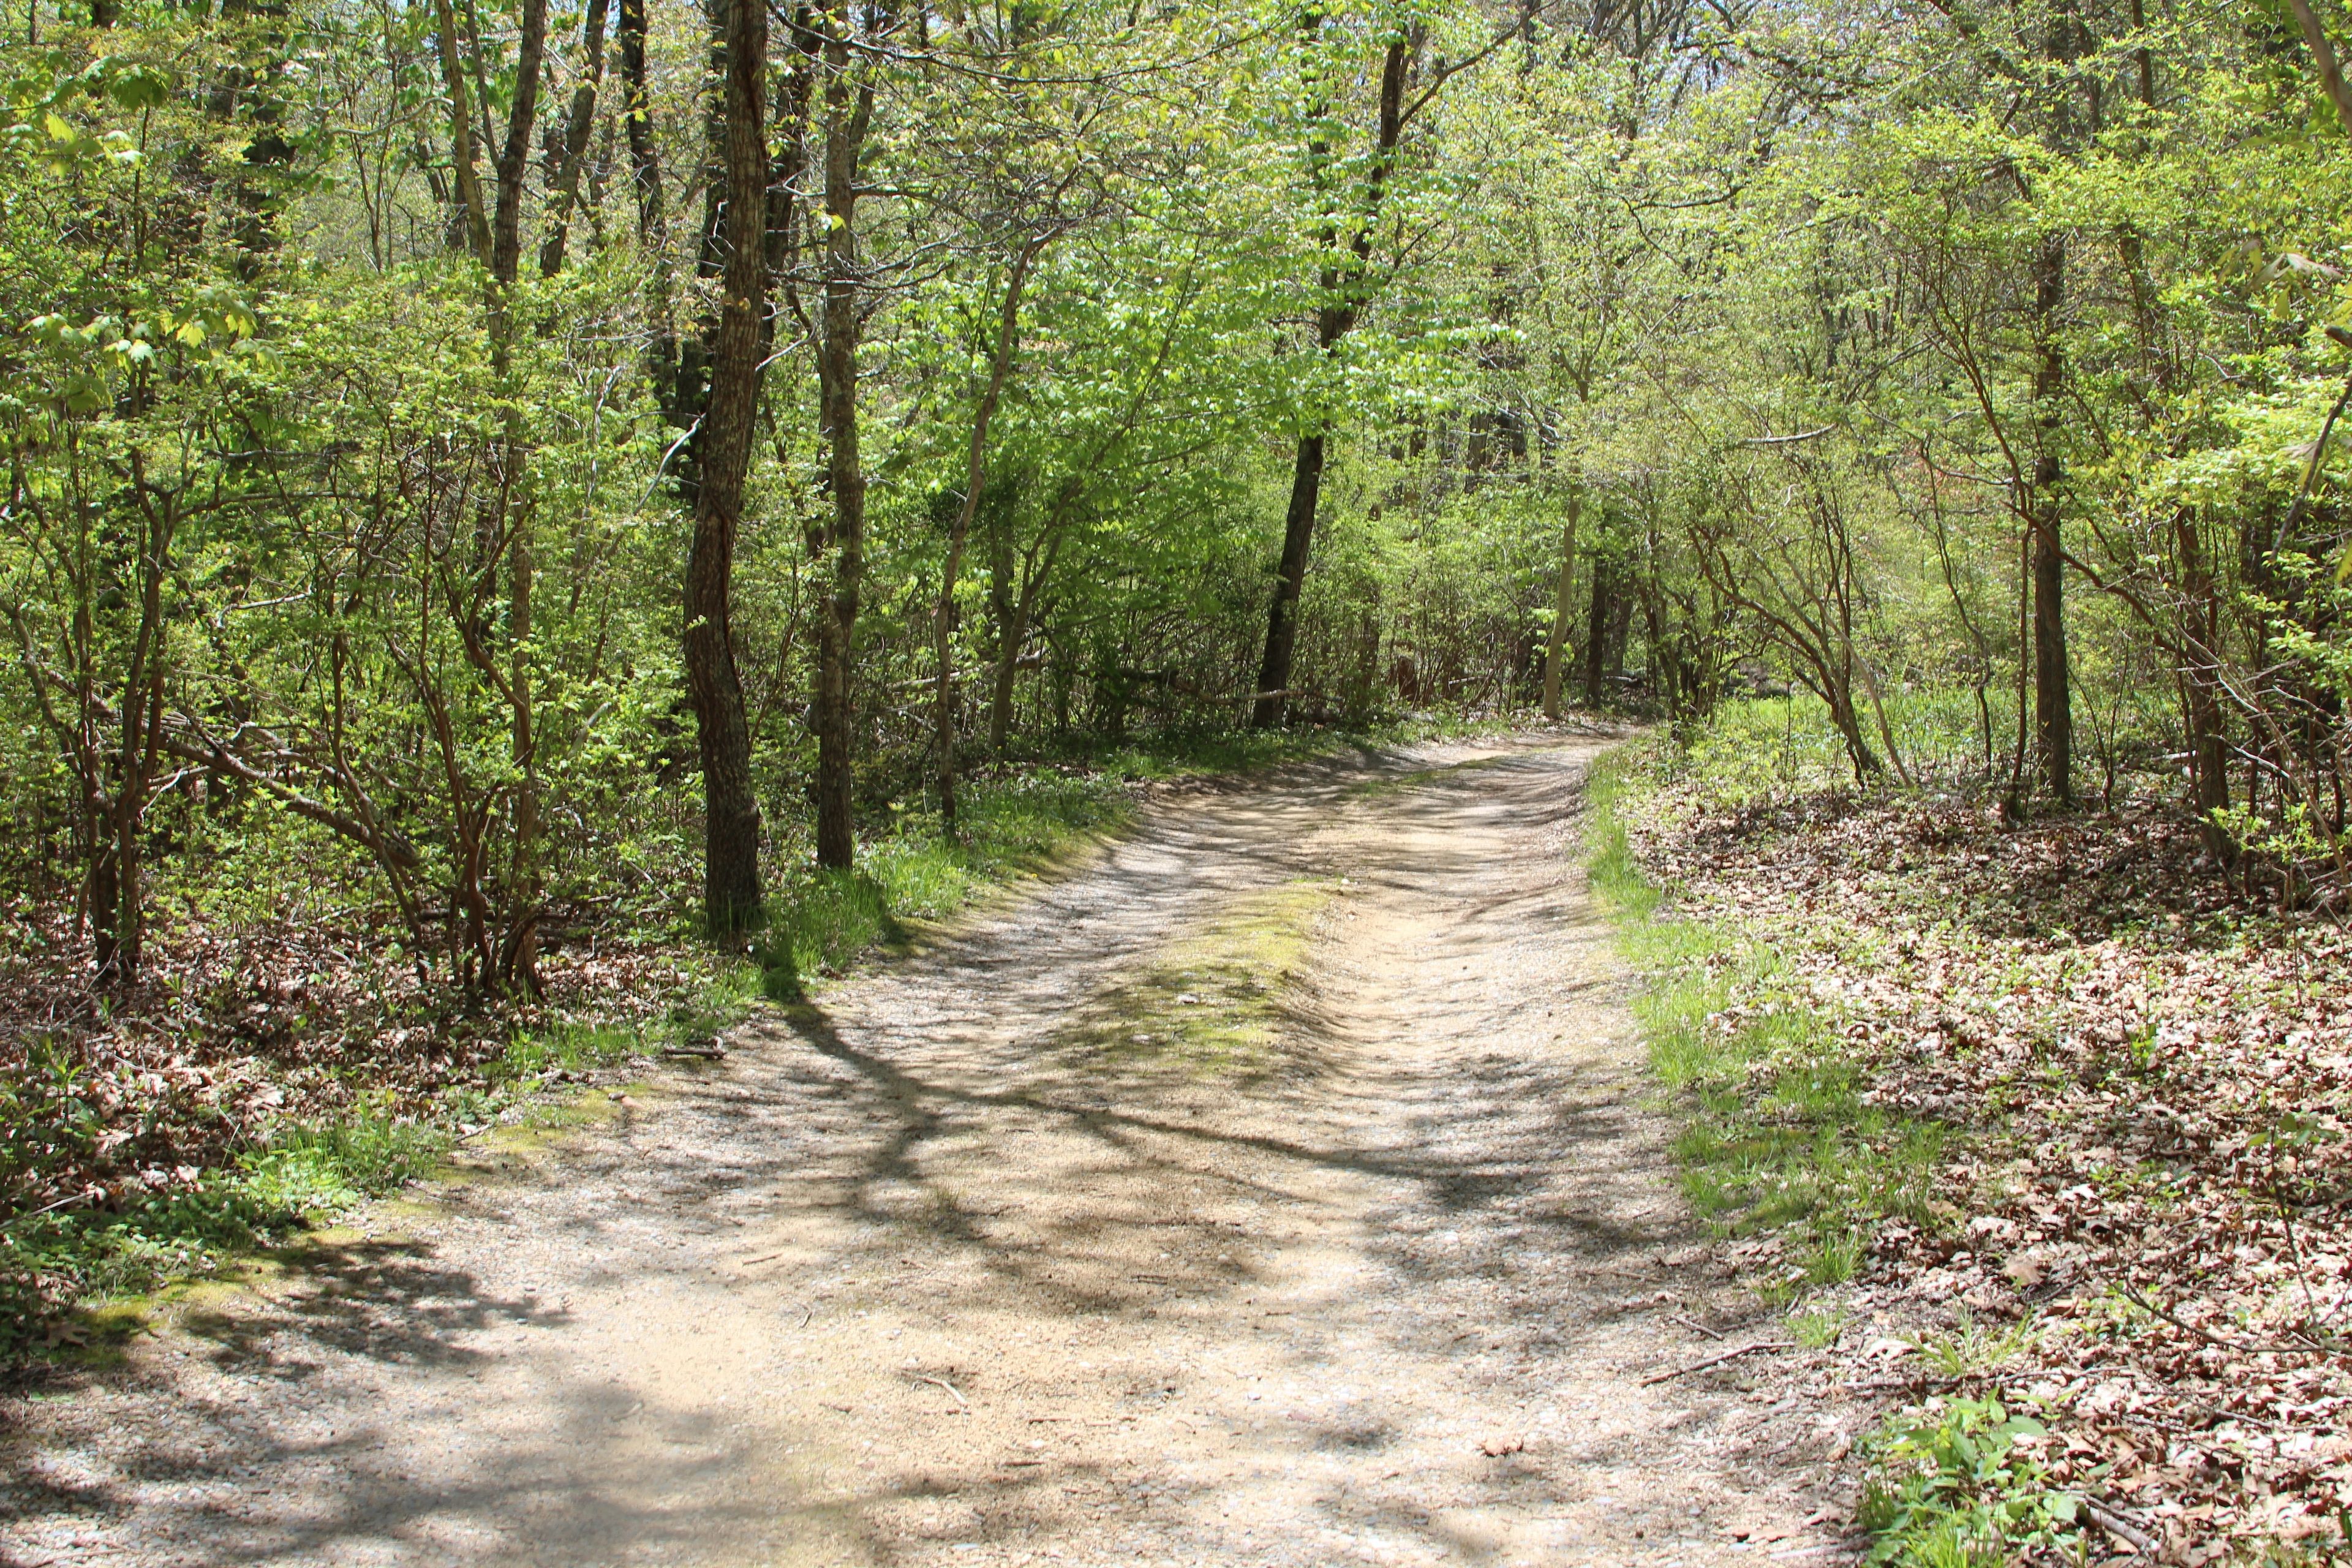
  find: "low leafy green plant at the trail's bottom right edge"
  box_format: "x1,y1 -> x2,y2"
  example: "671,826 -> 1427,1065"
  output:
1856,1399 -> 2086,1568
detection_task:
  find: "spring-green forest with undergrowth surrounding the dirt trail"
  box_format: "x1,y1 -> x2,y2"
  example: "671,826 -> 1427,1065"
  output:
0,0 -> 2352,1563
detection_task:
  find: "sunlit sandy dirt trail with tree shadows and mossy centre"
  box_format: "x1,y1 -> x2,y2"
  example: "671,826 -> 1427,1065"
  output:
0,745 -> 1837,1568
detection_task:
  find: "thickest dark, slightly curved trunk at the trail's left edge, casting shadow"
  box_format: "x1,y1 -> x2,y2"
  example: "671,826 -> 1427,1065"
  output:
682,0 -> 767,938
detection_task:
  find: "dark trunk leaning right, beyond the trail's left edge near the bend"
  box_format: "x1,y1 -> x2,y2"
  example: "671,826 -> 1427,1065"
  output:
1249,34 -> 1414,729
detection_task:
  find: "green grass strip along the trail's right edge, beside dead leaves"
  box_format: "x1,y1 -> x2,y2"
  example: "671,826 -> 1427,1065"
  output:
1585,748 -> 1943,1300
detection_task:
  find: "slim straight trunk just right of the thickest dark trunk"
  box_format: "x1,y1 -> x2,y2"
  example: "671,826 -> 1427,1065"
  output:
816,34 -> 873,870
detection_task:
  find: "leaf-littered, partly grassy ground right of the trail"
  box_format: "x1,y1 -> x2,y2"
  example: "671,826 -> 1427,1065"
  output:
1588,745 -> 2352,1566
